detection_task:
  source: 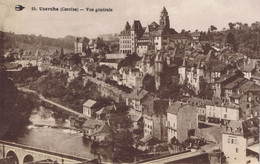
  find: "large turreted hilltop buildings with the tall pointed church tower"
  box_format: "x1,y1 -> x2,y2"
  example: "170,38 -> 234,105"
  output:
119,7 -> 192,56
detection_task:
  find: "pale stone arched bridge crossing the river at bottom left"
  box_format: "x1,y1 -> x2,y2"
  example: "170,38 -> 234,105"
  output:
0,140 -> 95,164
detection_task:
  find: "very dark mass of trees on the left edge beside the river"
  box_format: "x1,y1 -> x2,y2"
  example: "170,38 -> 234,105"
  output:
0,70 -> 37,137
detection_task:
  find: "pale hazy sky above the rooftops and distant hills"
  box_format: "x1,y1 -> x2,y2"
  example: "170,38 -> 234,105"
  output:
0,0 -> 260,38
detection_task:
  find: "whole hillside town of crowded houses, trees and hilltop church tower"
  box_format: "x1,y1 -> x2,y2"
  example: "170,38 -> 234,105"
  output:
0,7 -> 260,164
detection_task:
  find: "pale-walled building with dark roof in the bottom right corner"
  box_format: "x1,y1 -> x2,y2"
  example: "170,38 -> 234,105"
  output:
222,117 -> 259,163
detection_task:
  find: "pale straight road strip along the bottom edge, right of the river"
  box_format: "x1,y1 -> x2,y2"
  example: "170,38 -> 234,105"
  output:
140,151 -> 203,164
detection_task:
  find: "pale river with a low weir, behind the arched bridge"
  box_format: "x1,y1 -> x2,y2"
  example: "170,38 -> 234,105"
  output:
2,106 -> 110,162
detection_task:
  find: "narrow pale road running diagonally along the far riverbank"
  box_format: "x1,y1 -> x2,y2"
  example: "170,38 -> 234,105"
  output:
18,87 -> 87,118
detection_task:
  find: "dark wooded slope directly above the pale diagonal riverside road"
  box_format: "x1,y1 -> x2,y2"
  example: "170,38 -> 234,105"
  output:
30,72 -> 101,112
